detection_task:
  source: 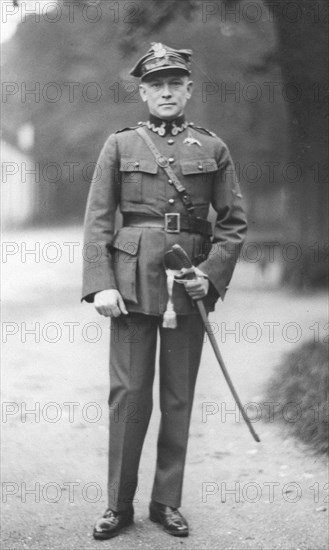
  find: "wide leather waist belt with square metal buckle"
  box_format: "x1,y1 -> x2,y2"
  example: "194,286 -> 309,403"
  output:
123,212 -> 212,237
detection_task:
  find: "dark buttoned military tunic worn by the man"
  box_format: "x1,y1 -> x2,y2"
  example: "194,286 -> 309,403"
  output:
82,124 -> 247,315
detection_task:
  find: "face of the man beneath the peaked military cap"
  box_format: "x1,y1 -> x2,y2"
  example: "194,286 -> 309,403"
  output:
139,70 -> 193,120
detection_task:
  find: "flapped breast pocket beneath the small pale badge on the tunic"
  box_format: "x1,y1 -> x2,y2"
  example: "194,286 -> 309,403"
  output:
180,158 -> 218,204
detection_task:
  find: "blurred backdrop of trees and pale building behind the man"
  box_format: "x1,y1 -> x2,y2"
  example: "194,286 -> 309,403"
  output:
2,0 -> 328,288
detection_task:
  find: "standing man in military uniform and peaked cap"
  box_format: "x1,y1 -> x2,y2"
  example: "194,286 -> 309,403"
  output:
83,43 -> 246,539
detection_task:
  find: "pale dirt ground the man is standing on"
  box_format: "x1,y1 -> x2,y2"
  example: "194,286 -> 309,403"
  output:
2,228 -> 328,550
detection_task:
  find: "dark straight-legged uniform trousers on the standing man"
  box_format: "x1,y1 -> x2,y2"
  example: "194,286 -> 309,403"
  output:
108,313 -> 204,511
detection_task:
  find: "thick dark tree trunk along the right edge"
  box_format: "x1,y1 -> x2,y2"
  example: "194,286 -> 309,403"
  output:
266,0 -> 328,287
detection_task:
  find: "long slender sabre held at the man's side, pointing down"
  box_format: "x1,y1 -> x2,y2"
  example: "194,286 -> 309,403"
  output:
164,244 -> 260,443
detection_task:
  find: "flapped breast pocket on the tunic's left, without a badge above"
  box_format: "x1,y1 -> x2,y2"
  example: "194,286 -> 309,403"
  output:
120,157 -> 158,203
